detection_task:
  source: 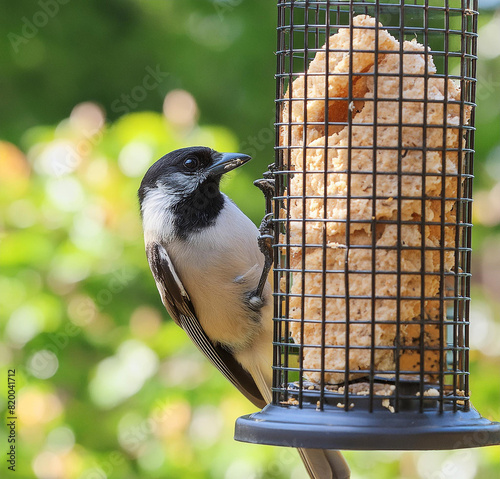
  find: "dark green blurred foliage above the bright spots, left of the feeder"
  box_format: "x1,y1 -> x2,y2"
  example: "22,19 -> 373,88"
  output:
0,0 -> 276,162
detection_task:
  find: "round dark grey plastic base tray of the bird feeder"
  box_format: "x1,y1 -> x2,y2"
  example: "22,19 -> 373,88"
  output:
235,382 -> 500,450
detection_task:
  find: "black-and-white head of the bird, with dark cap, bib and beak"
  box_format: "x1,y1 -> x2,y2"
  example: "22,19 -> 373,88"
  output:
138,146 -> 251,242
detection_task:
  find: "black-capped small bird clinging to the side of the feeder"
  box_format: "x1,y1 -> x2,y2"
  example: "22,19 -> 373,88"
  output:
138,146 -> 350,479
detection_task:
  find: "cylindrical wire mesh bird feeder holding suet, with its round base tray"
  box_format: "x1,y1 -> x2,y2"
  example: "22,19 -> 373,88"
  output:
236,0 -> 500,449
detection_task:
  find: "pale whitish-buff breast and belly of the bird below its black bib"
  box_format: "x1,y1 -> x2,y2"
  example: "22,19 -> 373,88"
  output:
163,197 -> 271,349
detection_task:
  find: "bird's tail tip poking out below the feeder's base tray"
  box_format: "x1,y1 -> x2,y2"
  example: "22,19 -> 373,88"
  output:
298,449 -> 351,479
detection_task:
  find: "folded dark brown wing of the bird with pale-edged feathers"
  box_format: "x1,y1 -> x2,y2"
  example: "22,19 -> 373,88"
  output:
146,243 -> 266,408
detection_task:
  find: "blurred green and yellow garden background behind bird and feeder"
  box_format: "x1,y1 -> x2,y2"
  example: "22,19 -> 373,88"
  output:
0,0 -> 500,479
